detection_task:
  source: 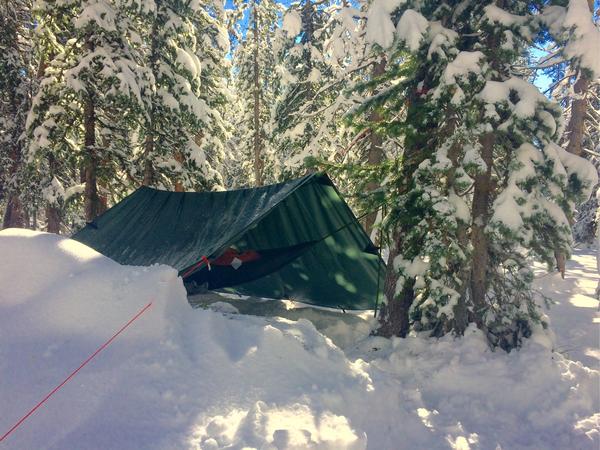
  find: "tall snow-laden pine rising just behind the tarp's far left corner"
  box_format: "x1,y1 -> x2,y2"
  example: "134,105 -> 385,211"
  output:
28,0 -> 142,225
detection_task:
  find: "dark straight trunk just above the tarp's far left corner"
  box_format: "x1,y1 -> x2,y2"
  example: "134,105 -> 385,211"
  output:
83,94 -> 101,222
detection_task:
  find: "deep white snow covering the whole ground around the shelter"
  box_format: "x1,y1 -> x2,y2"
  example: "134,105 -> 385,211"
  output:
0,230 -> 600,450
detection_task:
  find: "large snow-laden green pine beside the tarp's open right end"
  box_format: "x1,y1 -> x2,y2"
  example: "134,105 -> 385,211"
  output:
370,0 -> 595,350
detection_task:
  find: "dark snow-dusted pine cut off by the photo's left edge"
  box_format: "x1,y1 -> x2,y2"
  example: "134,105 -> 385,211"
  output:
0,0 -> 35,228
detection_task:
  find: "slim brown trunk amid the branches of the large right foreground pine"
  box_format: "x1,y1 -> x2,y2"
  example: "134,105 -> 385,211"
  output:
470,133 -> 494,326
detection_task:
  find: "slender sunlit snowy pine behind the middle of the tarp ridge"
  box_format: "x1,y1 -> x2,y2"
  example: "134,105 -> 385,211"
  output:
233,0 -> 281,186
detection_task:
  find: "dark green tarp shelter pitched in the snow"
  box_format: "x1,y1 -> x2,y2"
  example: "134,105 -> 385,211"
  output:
73,174 -> 385,309
